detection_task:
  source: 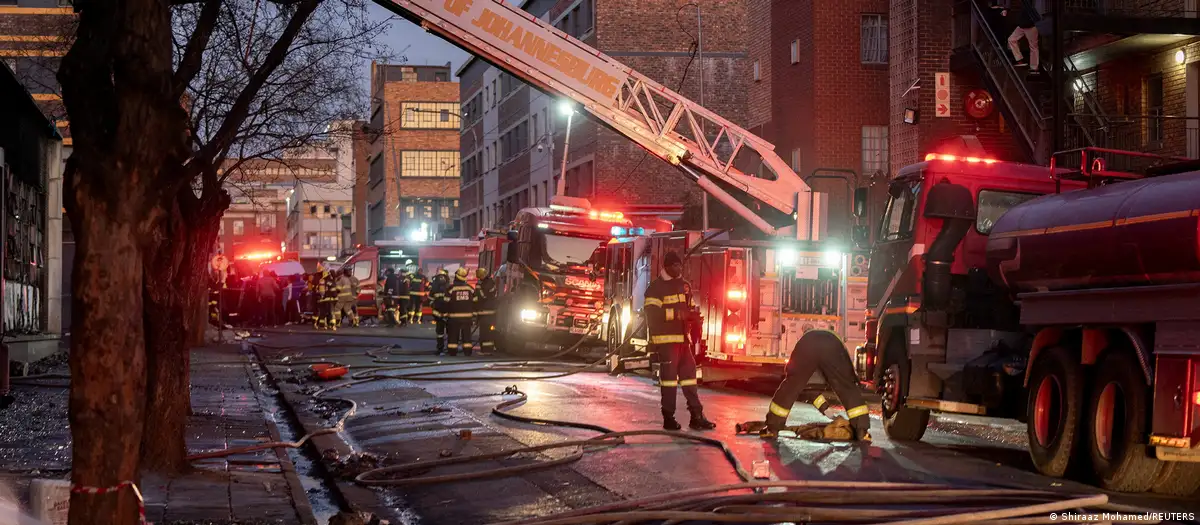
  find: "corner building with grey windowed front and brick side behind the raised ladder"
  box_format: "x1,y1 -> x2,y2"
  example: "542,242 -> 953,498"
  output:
458,0 -> 750,235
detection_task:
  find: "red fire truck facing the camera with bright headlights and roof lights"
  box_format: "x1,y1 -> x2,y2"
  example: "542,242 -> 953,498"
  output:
479,197 -> 643,351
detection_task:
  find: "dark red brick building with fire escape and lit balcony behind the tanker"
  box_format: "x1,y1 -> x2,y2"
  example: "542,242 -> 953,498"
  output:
889,0 -> 1200,178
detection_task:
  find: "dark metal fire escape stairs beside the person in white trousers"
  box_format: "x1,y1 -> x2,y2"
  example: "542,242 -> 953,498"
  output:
955,0 -> 1109,164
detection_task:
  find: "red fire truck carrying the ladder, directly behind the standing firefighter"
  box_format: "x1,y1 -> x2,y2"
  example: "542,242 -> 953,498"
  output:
601,230 -> 865,373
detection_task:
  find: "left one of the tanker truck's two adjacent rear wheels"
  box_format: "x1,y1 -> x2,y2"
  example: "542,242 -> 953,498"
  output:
1025,346 -> 1085,477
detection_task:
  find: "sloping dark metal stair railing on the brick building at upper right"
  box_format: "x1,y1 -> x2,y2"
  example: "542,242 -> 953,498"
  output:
959,0 -> 1050,163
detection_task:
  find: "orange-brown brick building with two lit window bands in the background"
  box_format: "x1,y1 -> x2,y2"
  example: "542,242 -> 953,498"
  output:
359,64 -> 460,242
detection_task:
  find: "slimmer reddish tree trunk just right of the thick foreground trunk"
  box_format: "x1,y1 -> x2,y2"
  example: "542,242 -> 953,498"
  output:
142,188 -> 228,475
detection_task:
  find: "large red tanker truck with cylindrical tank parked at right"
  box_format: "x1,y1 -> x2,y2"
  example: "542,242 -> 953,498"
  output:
858,149 -> 1200,495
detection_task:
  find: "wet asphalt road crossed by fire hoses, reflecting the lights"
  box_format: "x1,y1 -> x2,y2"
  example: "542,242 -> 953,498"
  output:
259,327 -> 1200,524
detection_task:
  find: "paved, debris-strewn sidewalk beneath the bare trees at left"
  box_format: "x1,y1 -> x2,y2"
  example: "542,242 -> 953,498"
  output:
0,345 -> 316,525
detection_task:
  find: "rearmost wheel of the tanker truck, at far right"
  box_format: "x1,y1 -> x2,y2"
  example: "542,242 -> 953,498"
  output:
1087,351 -> 1163,493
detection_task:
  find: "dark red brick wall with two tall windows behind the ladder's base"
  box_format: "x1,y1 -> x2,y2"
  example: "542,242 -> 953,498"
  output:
746,0 -> 889,240
